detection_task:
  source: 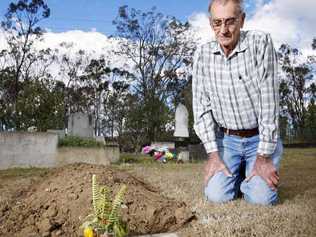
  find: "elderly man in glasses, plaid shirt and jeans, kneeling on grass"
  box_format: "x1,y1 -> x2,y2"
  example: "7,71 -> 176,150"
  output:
192,0 -> 283,205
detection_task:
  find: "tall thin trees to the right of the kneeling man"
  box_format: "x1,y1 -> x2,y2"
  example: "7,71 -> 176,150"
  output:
279,44 -> 316,143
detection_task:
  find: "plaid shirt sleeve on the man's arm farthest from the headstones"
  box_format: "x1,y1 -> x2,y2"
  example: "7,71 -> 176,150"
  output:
257,34 -> 279,155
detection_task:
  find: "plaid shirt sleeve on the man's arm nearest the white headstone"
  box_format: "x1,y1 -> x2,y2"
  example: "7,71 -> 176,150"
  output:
192,46 -> 218,153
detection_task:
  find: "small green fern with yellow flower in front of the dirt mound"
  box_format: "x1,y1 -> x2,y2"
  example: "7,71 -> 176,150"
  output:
81,175 -> 127,237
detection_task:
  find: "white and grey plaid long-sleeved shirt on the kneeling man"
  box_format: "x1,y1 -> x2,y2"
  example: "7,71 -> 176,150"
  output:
192,31 -> 279,155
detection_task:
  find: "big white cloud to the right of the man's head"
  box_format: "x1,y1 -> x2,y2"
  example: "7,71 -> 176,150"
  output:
245,0 -> 316,49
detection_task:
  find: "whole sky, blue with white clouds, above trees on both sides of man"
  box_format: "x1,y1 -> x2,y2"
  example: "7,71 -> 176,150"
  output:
0,0 -> 316,54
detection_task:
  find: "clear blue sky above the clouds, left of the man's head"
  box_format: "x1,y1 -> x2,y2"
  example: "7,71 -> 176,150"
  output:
0,0 -> 215,35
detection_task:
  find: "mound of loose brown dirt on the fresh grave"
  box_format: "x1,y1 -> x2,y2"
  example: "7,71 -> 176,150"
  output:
0,164 -> 194,237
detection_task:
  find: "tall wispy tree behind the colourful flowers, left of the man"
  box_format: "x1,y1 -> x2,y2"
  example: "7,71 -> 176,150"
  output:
113,6 -> 194,141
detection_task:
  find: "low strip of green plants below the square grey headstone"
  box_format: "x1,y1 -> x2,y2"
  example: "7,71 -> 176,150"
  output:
58,136 -> 104,147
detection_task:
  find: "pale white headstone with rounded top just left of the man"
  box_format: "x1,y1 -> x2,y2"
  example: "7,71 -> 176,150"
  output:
173,103 -> 189,137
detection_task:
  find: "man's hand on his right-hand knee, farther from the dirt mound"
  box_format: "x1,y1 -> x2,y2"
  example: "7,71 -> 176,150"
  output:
245,154 -> 279,191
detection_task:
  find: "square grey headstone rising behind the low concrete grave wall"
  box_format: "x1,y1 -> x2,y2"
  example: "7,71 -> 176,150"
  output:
68,113 -> 94,138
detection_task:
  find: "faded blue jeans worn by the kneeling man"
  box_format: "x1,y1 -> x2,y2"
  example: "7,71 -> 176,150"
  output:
204,135 -> 283,205
